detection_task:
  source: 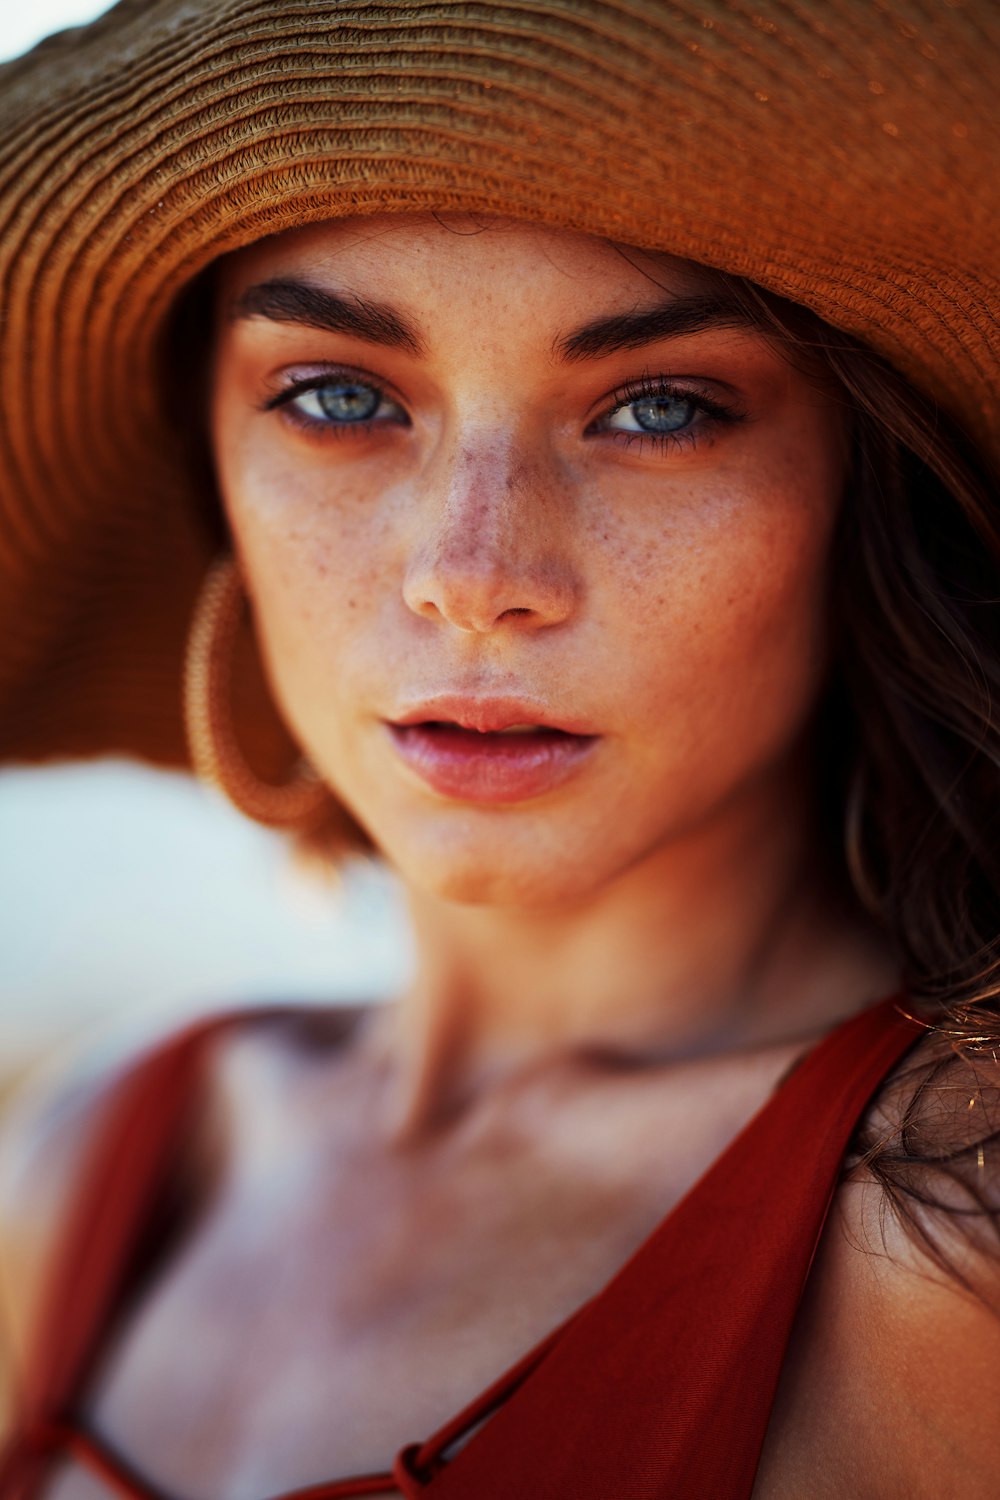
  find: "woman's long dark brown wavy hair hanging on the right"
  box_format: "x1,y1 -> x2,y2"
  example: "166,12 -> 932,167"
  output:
716,278 -> 1000,1281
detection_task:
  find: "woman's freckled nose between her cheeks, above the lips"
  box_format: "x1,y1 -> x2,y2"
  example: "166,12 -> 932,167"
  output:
403,441 -> 579,633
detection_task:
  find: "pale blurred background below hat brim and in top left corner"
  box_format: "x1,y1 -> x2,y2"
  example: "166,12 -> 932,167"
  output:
0,0 -> 411,1101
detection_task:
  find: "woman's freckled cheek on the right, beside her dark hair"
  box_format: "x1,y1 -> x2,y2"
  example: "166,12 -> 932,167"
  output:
593,450 -> 840,756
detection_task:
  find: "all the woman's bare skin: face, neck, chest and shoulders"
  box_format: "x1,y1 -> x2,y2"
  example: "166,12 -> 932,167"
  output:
7,219 -> 1000,1500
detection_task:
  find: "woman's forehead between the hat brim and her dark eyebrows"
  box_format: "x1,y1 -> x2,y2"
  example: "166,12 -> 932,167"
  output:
222,215 -> 720,318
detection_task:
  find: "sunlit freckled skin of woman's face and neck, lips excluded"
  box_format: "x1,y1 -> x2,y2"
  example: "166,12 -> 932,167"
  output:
211,219 -> 893,1122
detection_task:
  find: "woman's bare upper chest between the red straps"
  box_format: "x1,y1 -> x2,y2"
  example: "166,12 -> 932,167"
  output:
43,1038 -> 863,1500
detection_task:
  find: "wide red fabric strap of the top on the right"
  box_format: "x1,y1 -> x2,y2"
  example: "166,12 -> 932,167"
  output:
419,999 -> 925,1500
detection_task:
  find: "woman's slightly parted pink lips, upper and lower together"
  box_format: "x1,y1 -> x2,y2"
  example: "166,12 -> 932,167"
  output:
387,701 -> 598,804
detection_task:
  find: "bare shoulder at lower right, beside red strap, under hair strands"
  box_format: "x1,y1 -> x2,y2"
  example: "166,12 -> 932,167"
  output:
754,1038 -> 1000,1500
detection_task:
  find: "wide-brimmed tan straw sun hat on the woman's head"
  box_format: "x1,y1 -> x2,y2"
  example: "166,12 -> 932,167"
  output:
0,0 -> 1000,798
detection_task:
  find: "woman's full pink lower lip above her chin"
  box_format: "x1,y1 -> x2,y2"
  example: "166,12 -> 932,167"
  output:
388,725 -> 597,803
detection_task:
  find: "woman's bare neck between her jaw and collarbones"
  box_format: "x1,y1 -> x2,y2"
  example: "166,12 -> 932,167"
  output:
370,762 -> 897,1134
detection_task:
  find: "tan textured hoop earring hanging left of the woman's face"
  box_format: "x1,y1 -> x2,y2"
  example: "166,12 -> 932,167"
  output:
184,555 -> 331,831
